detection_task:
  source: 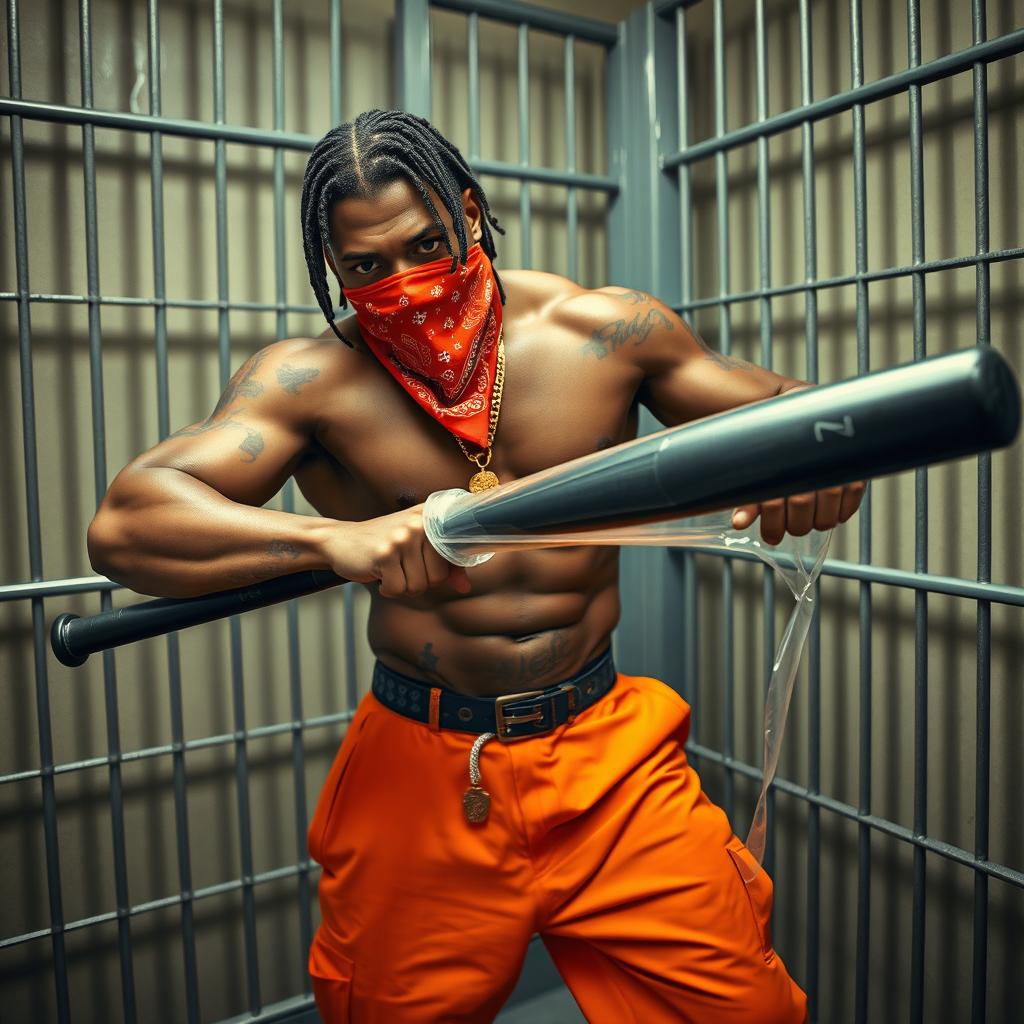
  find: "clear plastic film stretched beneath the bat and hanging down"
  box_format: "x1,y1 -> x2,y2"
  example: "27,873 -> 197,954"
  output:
423,483 -> 831,864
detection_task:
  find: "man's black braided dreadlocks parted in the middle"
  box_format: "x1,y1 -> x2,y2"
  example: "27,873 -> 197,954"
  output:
301,110 -> 505,347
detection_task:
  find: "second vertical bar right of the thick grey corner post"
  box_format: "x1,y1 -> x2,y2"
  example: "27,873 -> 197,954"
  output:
714,0 -> 736,821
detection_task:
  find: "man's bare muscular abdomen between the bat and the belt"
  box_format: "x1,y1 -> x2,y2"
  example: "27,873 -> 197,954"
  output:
368,547 -> 620,696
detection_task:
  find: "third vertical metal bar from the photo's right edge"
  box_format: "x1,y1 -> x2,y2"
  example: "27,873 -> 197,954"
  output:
850,0 -> 871,1024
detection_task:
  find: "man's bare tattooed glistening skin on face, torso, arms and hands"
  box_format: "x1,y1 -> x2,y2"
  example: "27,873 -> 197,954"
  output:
90,181 -> 862,696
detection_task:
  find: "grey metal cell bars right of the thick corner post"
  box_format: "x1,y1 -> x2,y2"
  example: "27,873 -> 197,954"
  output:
655,0 -> 1024,1024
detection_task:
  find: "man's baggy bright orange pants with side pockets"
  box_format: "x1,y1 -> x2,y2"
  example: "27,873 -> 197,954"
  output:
308,673 -> 807,1024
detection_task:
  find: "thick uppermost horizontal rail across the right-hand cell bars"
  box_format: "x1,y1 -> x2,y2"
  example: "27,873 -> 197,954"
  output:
662,29 -> 1024,171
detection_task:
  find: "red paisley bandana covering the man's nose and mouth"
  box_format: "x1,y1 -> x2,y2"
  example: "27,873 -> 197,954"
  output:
345,244 -> 502,447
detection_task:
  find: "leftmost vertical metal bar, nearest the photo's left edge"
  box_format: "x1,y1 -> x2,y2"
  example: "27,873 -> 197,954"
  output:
7,0 -> 71,1024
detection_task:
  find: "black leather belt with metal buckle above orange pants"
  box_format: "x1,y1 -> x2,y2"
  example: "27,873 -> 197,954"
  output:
372,647 -> 616,742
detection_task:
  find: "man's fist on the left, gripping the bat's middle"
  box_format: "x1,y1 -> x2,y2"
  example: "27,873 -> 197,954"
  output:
321,504 -> 470,597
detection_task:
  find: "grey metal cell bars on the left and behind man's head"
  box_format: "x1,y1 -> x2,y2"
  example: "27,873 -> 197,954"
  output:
0,0 -> 618,1024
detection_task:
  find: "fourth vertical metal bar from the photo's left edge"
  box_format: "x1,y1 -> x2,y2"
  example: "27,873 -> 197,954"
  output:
213,0 -> 261,1016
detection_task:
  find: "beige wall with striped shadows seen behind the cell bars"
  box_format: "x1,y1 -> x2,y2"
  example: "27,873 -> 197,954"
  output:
0,0 -> 1024,1021
